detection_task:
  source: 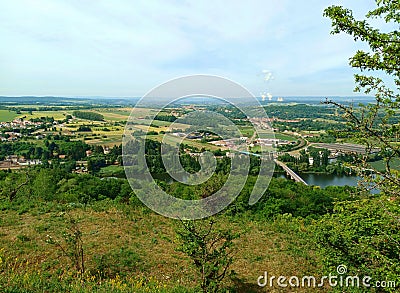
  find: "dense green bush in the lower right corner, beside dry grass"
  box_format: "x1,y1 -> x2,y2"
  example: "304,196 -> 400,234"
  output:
314,199 -> 400,291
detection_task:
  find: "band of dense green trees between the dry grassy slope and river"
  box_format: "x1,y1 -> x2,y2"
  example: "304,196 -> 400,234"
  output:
0,163 -> 358,220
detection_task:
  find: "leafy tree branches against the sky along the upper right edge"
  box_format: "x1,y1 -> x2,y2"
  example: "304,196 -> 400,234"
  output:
324,0 -> 400,197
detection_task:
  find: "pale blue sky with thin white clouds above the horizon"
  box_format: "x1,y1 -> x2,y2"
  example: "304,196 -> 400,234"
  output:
0,0 -> 382,97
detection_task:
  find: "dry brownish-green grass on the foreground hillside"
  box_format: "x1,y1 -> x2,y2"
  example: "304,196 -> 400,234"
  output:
0,200 -> 319,292
